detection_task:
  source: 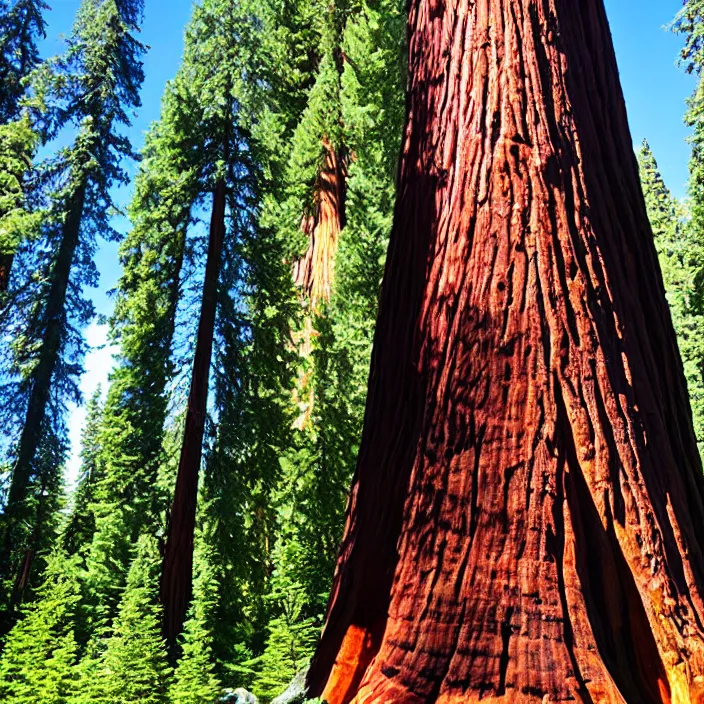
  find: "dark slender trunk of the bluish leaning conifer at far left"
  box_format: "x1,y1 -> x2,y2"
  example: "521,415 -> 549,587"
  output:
3,186 -> 85,578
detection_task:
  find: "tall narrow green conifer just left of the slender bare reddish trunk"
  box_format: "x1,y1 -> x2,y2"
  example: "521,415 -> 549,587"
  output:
80,75 -> 198,619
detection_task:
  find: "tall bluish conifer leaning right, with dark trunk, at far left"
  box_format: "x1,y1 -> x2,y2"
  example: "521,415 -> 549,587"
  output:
0,0 -> 143,601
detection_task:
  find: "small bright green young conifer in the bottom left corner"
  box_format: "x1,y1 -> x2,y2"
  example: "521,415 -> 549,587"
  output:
0,552 -> 79,704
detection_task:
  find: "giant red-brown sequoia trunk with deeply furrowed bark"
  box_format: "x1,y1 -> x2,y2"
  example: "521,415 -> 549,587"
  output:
308,0 -> 704,704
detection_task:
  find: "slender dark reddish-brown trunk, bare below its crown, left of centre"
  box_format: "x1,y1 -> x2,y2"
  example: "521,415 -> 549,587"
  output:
161,178 -> 226,647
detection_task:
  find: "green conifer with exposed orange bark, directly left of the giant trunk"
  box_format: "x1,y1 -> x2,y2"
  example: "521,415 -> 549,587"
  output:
258,2 -> 405,659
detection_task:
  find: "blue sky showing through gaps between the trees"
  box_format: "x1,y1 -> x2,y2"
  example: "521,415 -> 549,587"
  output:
42,0 -> 694,476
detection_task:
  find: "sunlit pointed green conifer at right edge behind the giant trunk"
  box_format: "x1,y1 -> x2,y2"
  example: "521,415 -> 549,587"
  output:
638,142 -> 704,453
